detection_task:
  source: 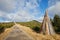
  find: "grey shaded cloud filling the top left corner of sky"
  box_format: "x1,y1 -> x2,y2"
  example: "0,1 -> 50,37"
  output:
0,0 -> 17,12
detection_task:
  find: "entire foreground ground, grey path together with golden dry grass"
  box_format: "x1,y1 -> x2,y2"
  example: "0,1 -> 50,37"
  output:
0,24 -> 60,40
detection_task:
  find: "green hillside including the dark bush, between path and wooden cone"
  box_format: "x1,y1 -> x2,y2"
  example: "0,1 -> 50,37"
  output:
17,20 -> 41,32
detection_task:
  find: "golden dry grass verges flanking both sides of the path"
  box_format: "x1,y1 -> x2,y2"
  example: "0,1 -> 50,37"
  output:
0,24 -> 60,40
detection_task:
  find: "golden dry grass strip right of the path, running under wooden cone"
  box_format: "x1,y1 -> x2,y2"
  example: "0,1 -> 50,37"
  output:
18,25 -> 60,40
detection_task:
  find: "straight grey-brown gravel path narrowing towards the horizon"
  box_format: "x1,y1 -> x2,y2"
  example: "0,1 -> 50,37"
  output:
4,25 -> 34,40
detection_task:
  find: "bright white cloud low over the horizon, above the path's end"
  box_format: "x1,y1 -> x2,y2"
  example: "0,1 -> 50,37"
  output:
8,11 -> 34,21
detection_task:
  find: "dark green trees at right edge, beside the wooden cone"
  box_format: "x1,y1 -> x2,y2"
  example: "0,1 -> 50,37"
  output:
52,14 -> 60,34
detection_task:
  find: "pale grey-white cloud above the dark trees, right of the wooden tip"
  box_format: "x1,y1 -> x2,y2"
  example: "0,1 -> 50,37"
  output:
48,0 -> 60,17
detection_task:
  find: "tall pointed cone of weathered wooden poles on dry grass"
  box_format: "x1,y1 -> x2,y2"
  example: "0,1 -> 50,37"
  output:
41,10 -> 55,35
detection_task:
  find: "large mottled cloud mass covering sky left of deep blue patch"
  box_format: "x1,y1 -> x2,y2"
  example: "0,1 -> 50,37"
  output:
0,0 -> 40,21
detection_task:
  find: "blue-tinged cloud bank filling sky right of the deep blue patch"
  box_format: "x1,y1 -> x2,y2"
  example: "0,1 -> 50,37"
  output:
48,0 -> 60,17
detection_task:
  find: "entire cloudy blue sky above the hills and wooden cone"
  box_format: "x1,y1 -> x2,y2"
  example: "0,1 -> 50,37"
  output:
0,0 -> 60,22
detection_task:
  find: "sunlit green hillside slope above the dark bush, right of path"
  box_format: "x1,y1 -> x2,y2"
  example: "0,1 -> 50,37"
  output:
17,20 -> 41,28
